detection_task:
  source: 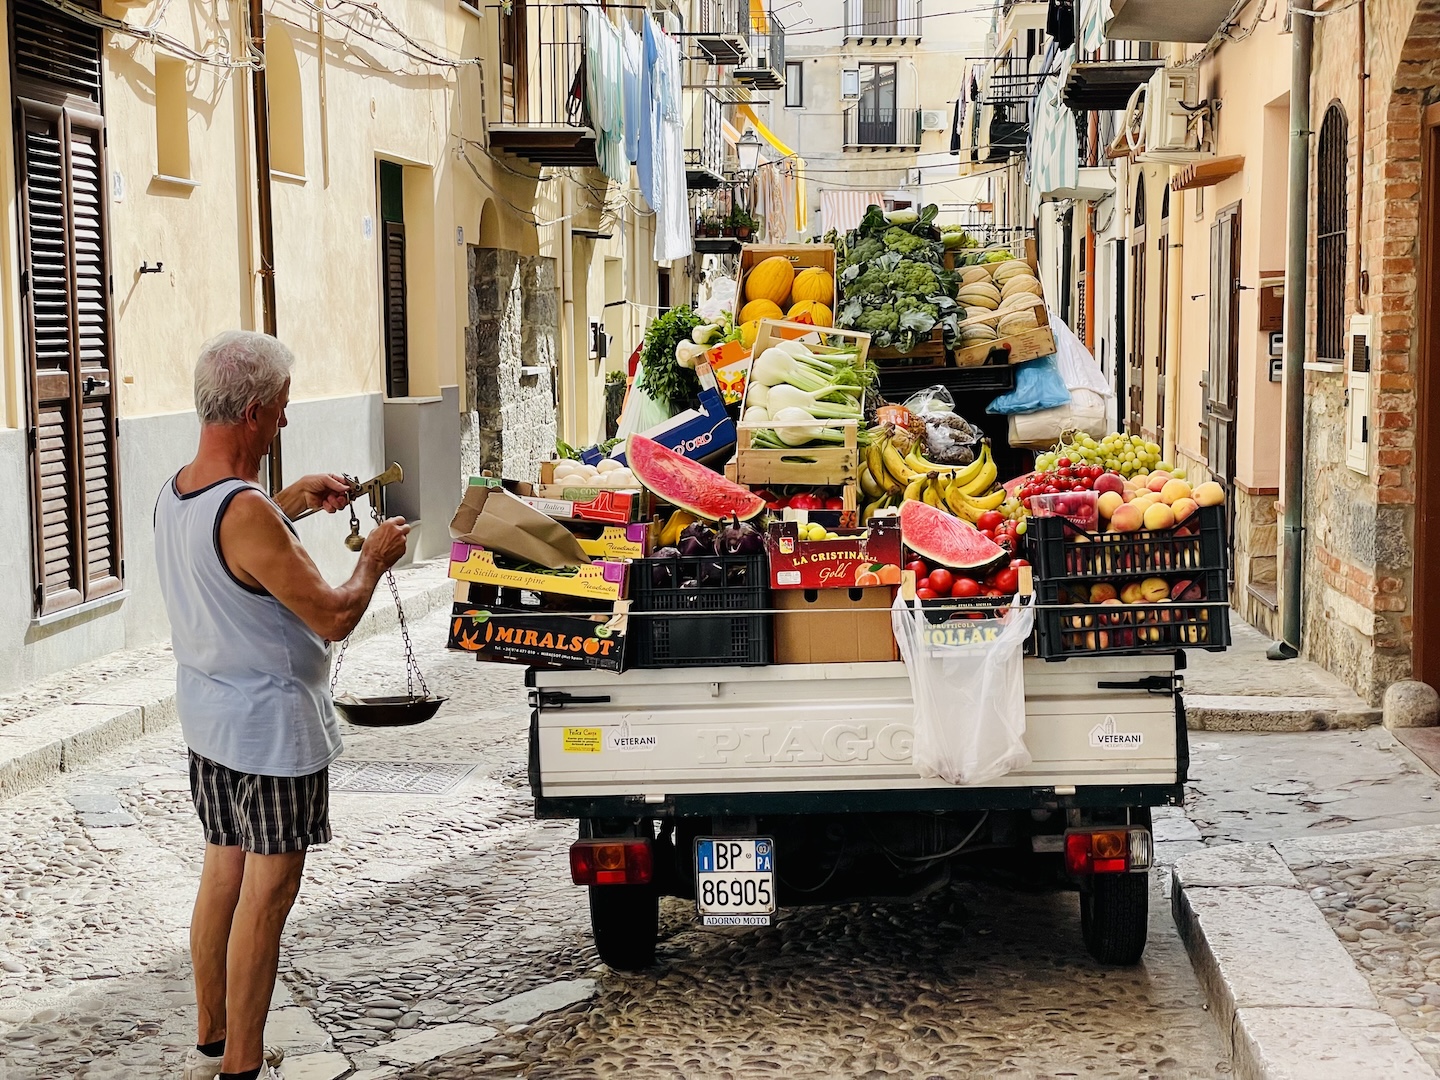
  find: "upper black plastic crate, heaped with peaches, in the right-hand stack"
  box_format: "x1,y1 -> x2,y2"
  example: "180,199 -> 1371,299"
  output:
1025,505 -> 1230,584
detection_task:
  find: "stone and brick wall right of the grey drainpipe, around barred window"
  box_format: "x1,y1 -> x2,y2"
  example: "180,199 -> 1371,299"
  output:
1305,0 -> 1440,703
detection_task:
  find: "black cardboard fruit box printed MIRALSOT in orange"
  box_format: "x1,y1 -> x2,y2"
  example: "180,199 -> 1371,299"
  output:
446,586 -> 629,671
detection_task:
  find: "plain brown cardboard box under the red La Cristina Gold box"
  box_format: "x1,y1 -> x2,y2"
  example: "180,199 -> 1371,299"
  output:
775,586 -> 899,664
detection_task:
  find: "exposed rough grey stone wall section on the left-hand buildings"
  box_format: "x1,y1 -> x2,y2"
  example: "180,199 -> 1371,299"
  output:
461,246 -> 560,480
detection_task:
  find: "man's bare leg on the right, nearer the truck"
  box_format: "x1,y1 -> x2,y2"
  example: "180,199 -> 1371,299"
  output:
220,851 -> 305,1073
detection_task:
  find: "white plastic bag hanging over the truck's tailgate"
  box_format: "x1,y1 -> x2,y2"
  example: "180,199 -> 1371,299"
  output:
890,596 -> 1035,785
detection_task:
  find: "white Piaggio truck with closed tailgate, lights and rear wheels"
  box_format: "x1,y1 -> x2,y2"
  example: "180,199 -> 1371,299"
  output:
527,652 -> 1189,971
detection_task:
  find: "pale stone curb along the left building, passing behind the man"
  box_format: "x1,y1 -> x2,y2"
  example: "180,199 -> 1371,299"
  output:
0,560 -> 455,802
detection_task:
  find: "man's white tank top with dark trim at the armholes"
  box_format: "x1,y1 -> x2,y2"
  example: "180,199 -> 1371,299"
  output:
156,478 -> 341,776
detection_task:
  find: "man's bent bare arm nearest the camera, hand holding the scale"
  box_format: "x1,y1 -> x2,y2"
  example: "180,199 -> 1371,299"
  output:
220,491 -> 409,641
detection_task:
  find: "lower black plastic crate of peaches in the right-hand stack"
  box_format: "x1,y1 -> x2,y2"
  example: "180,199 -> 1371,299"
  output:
1035,596 -> 1230,660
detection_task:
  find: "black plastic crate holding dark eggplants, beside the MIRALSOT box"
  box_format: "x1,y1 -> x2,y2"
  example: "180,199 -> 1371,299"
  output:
629,553 -> 772,668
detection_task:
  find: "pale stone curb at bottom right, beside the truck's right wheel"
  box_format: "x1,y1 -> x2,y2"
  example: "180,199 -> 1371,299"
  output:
1171,834 -> 1436,1080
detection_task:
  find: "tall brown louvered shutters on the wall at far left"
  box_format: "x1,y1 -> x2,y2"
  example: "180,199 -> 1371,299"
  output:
10,0 -> 125,615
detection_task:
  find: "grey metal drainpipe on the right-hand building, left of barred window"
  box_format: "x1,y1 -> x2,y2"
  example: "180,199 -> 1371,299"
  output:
1267,1 -> 1315,660
